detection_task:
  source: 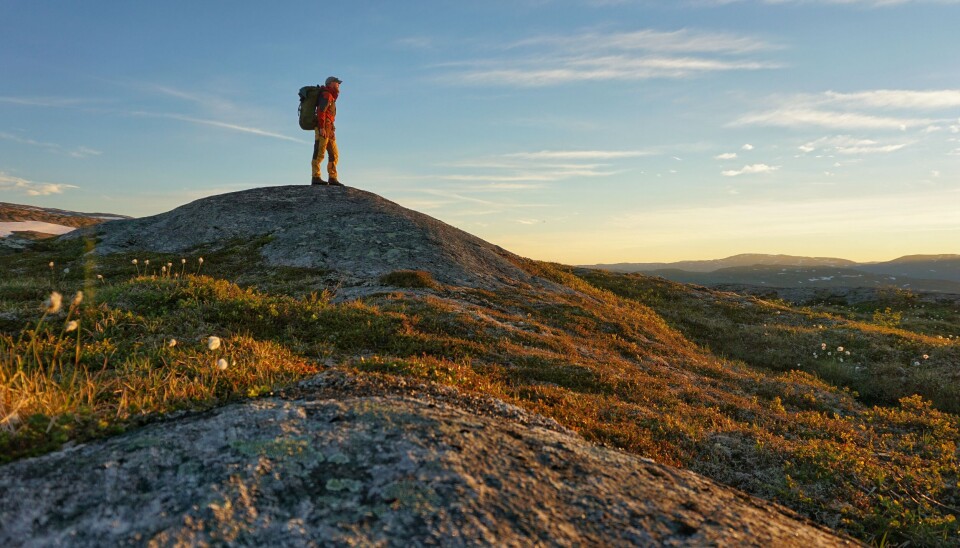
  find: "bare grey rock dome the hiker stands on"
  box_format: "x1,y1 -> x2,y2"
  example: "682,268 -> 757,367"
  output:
85,185 -> 535,288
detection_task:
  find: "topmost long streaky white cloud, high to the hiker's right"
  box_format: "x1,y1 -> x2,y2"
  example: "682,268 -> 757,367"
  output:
434,29 -> 780,87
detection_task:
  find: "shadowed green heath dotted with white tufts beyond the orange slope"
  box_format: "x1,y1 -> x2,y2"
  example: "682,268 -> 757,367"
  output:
581,270 -> 960,414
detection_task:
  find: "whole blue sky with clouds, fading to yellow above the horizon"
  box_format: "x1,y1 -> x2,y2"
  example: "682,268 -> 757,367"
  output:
0,0 -> 960,264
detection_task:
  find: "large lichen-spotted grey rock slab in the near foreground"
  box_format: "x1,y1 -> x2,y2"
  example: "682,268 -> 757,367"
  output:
0,379 -> 855,546
